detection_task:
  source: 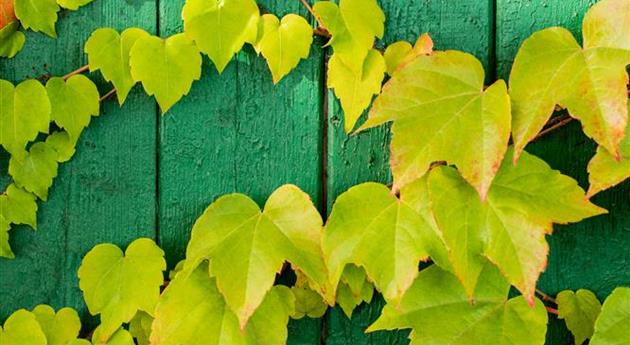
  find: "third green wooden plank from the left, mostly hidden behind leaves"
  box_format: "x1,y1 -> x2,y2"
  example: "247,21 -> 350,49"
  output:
326,0 -> 493,345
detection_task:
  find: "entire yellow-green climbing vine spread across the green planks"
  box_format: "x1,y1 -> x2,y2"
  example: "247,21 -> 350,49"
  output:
0,0 -> 630,345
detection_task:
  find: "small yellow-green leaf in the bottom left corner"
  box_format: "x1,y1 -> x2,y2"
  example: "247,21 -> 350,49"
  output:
0,309 -> 47,345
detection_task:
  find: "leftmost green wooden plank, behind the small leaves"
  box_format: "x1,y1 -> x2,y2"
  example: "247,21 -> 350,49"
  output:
0,0 -> 156,319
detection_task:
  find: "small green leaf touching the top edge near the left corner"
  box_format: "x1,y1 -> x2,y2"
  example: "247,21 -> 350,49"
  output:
15,0 -> 59,38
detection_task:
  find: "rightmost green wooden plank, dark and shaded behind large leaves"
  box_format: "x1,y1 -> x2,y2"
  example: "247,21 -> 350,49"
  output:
497,0 -> 630,345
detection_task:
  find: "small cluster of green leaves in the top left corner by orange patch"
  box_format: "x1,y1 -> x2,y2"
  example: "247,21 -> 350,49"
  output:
0,0 -> 94,58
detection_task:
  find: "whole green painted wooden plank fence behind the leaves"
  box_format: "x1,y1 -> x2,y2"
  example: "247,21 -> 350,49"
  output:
0,0 -> 630,345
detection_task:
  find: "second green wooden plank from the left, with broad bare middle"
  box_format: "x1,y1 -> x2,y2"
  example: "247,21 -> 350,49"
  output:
159,0 -> 323,344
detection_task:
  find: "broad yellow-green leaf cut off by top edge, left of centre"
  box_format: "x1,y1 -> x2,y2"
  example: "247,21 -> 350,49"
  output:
182,0 -> 260,73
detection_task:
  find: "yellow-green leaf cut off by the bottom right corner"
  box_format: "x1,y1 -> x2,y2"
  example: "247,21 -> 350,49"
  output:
589,287 -> 630,345
